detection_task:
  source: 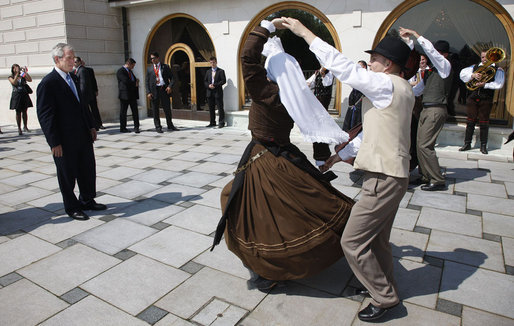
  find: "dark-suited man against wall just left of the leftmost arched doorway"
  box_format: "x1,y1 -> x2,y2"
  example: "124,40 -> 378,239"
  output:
116,58 -> 139,134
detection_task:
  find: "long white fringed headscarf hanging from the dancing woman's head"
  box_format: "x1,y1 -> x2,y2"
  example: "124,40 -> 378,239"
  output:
262,36 -> 348,144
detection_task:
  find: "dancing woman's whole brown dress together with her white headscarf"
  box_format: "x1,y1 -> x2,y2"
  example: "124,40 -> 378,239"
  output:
213,22 -> 354,280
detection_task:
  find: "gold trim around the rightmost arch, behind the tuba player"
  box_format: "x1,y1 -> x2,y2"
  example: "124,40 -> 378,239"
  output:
373,0 -> 514,127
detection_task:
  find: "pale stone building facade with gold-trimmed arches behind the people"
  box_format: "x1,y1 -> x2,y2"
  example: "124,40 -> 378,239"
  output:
0,0 -> 514,135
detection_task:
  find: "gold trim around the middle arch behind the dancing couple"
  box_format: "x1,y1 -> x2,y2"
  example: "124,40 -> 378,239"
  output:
237,1 -> 341,114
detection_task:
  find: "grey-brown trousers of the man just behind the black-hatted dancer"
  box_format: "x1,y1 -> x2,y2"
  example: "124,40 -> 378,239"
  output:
416,106 -> 447,184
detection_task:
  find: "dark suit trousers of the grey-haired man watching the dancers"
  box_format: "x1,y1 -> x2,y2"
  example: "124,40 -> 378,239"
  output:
54,140 -> 96,213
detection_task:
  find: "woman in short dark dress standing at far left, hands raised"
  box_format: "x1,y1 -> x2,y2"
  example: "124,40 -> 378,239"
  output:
8,63 -> 33,135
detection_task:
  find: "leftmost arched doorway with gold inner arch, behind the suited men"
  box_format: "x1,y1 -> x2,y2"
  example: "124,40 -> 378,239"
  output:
143,14 -> 216,121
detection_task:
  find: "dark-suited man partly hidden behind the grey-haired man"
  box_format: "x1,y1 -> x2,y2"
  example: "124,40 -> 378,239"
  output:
74,57 -> 105,131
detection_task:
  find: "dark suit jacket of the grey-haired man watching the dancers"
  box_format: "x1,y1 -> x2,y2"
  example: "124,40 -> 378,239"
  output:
36,69 -> 94,148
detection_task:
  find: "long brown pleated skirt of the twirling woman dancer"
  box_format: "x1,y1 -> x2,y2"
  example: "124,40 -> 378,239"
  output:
221,144 -> 354,280
